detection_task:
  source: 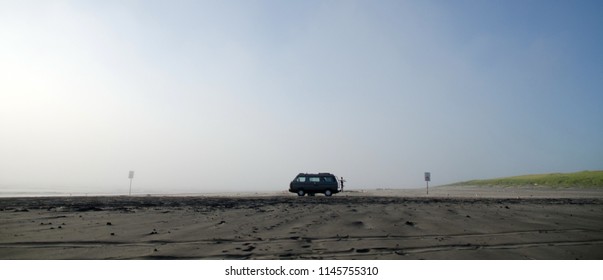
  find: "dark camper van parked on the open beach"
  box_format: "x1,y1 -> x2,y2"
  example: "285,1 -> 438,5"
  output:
289,173 -> 340,196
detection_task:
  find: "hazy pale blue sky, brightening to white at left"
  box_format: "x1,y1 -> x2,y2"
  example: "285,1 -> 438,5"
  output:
0,0 -> 603,193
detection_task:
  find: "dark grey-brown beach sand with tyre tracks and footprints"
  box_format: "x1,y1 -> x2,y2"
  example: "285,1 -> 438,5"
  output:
0,187 -> 603,259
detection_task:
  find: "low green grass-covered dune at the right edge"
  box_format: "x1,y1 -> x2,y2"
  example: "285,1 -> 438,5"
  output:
453,171 -> 603,187
